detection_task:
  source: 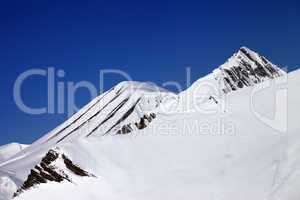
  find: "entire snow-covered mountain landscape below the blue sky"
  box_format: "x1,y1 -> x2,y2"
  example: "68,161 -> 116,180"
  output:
0,47 -> 300,200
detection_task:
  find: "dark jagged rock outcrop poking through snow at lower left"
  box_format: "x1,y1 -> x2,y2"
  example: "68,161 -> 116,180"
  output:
14,150 -> 94,197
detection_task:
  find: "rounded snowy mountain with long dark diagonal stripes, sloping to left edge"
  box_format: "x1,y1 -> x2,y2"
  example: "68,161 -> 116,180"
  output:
0,81 -> 176,186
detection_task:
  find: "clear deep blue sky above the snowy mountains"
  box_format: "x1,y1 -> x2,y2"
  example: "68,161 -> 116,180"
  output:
0,0 -> 300,145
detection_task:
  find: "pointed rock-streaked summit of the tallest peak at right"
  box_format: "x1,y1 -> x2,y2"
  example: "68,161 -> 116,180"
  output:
213,47 -> 285,93
